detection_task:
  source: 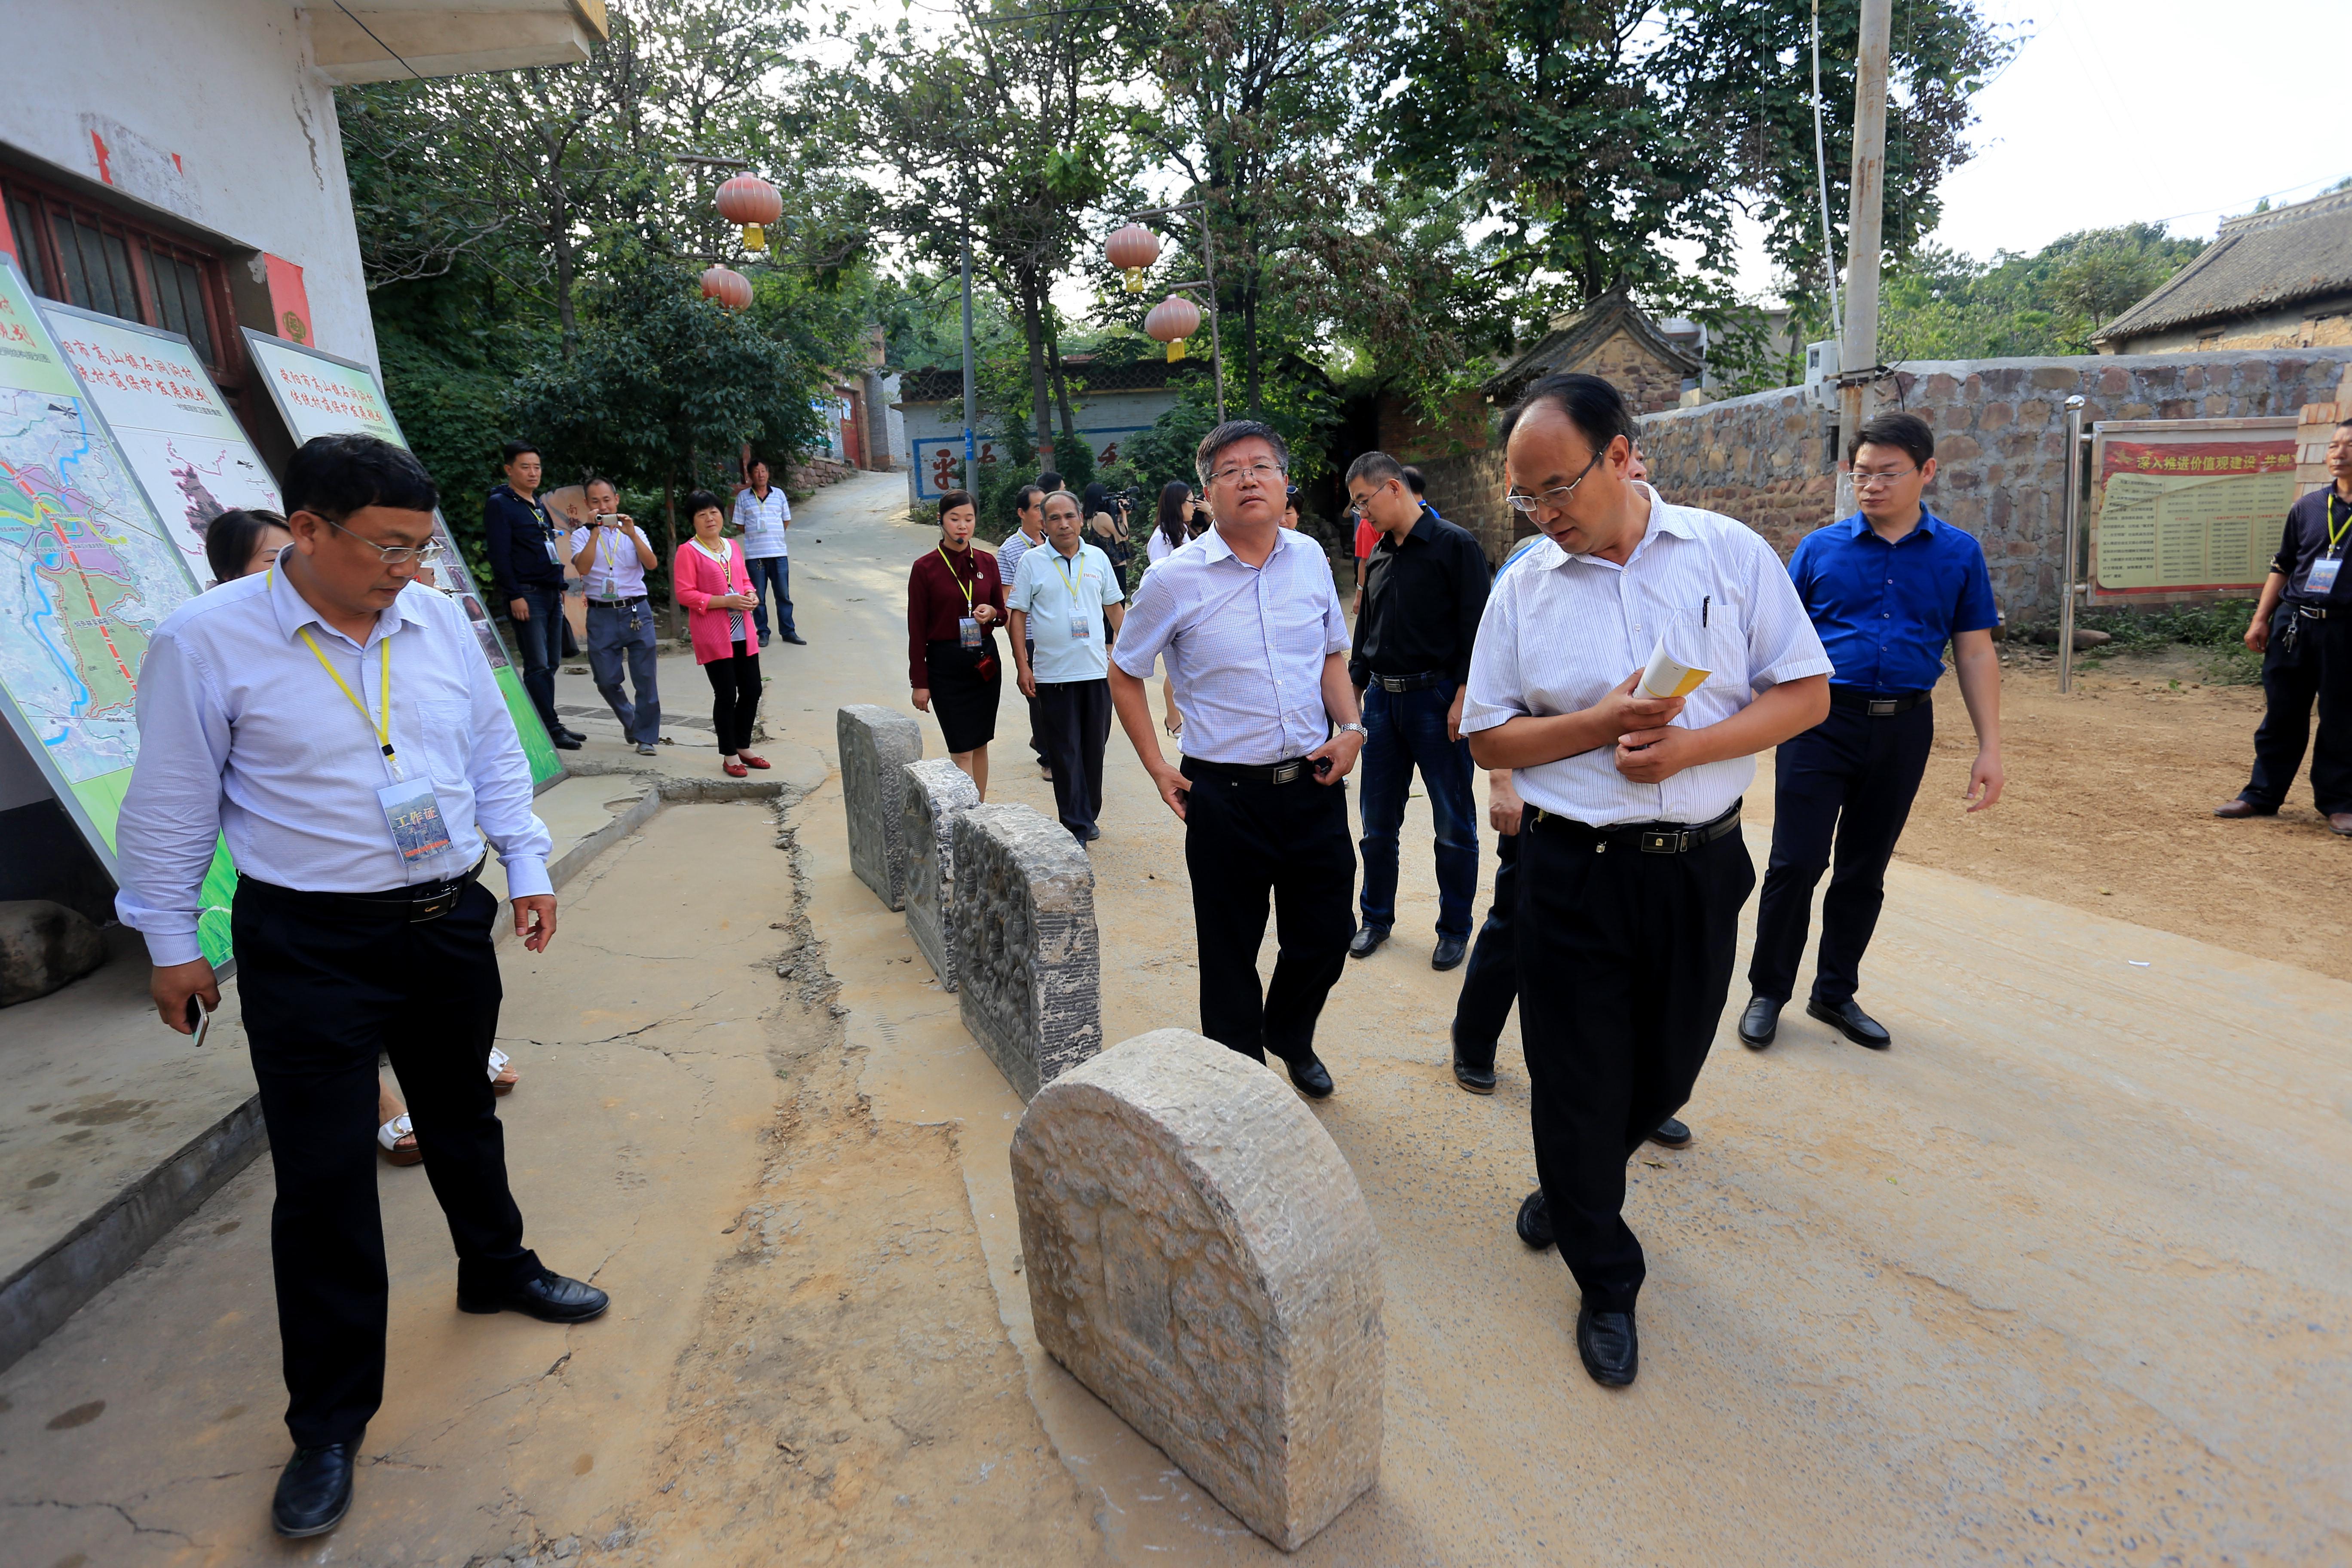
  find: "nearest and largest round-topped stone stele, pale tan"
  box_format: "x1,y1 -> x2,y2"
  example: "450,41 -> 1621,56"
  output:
1011,1030 -> 1385,1552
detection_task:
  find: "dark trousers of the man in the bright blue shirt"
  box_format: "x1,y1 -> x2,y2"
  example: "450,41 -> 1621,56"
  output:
1748,703 -> 1936,1006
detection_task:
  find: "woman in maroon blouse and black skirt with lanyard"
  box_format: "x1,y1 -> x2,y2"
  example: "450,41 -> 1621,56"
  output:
906,489 -> 1004,799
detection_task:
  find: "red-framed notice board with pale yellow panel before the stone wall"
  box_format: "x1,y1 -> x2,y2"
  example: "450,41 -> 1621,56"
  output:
2091,421 -> 2296,604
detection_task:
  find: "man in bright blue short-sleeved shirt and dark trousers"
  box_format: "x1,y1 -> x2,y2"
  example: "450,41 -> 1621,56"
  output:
1740,414 -> 2002,1051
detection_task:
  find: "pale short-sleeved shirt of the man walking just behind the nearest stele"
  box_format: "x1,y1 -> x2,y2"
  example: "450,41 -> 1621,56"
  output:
1110,529 -> 1348,766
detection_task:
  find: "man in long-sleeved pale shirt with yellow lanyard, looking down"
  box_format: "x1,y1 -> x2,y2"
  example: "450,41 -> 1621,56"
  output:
115,435 -> 607,1535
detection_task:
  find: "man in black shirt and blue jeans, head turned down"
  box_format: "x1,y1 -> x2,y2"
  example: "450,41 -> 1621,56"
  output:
1348,451 -> 1491,968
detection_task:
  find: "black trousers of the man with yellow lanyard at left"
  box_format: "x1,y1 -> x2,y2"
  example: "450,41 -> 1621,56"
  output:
230,879 -> 539,1446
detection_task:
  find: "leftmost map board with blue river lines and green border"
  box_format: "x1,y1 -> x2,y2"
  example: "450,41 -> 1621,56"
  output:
0,256 -> 238,966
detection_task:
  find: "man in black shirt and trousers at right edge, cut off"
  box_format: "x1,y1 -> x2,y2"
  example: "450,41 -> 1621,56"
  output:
2213,419 -> 2352,837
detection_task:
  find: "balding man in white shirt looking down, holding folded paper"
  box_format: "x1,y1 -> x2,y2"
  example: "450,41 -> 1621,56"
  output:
1463,374 -> 1830,1387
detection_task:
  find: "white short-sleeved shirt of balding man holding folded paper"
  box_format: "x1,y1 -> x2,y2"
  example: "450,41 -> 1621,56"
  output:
1467,487 -> 1830,827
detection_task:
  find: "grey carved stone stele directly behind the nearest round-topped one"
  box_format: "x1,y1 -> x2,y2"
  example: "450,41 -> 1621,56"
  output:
950,806 -> 1103,1100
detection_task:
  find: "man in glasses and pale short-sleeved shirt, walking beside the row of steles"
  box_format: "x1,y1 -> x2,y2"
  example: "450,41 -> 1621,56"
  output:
1110,419 -> 1364,1100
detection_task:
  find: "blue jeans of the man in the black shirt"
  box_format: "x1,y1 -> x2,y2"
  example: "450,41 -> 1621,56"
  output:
1362,682 -> 1477,940
